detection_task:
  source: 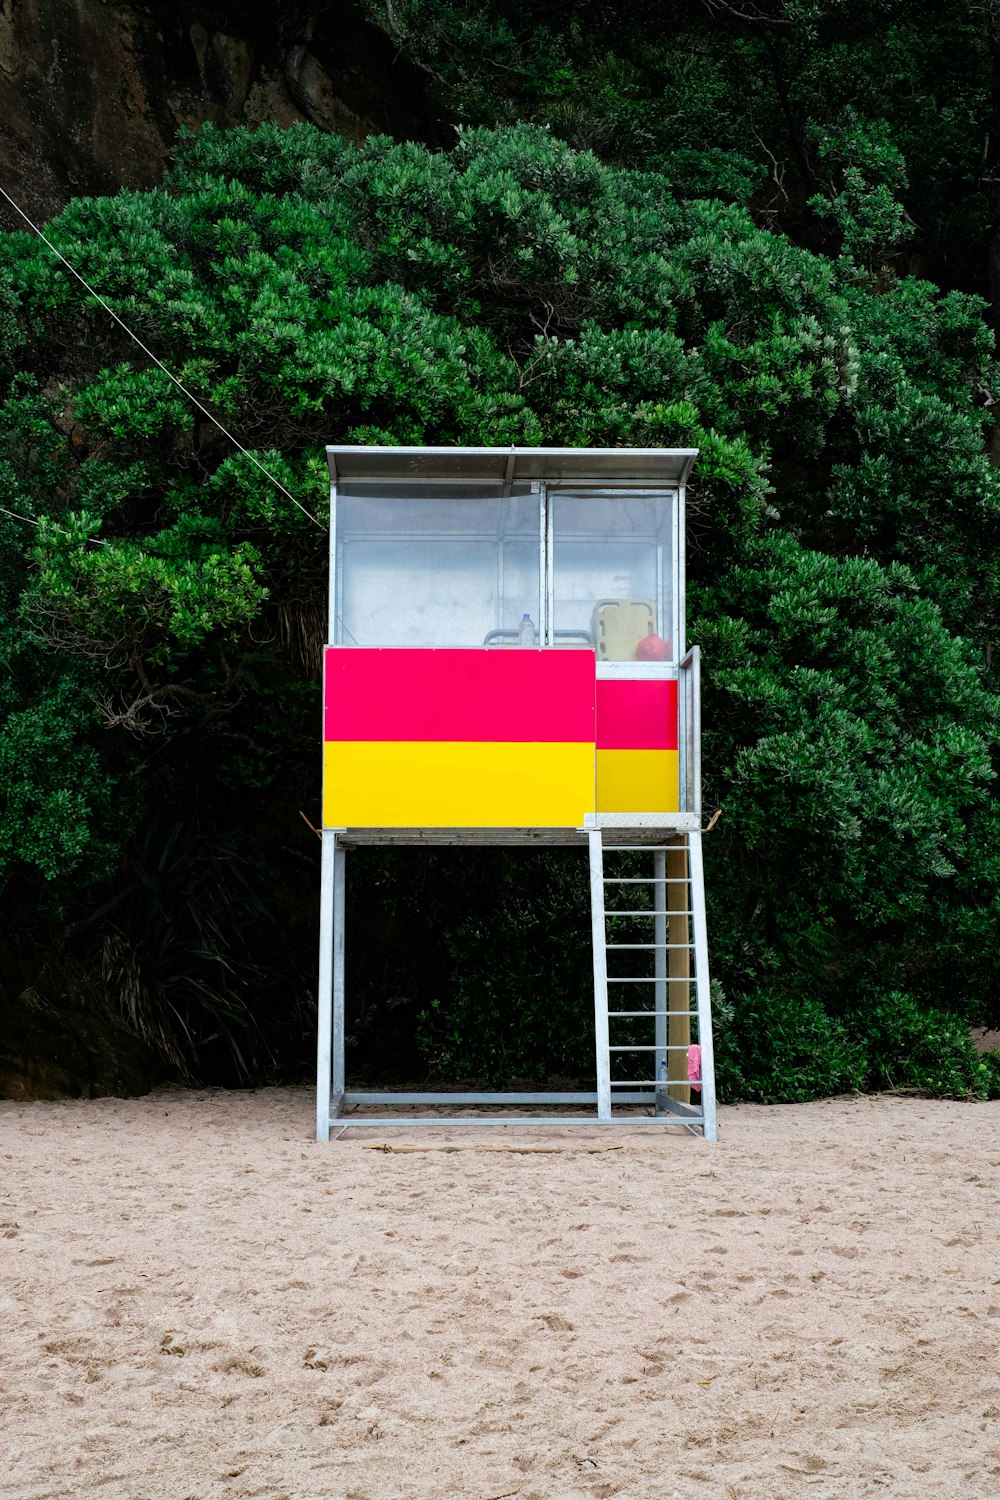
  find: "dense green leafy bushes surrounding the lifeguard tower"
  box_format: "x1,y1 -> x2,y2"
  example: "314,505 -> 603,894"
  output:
0,128 -> 1000,1098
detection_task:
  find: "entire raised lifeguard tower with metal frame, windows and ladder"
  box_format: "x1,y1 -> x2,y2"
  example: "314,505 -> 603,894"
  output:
316,447 -> 715,1140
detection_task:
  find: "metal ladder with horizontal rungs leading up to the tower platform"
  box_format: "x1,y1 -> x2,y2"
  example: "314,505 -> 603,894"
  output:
588,828 -> 718,1140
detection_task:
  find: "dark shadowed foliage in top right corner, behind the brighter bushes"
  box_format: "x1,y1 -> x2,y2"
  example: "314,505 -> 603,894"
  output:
366,0 -> 996,290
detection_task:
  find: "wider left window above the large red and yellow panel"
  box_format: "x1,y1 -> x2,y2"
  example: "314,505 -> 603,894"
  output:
334,485 -> 541,647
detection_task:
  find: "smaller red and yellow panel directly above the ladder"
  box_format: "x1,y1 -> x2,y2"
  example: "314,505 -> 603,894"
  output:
597,678 -> 681,813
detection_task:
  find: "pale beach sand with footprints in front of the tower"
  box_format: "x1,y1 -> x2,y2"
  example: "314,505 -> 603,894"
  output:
0,1089 -> 1000,1500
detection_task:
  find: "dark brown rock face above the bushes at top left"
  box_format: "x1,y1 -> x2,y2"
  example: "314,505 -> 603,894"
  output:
0,0 -> 441,228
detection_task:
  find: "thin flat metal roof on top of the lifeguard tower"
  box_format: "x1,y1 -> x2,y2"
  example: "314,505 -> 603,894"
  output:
327,444 -> 699,486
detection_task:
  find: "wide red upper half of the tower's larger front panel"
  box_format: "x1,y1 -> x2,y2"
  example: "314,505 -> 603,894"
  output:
325,647 -> 595,744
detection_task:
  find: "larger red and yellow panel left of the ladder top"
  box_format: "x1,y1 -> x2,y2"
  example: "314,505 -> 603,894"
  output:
324,647 -> 595,828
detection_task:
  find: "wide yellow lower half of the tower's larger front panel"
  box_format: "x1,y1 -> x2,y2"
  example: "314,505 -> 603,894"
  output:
324,740 -> 594,828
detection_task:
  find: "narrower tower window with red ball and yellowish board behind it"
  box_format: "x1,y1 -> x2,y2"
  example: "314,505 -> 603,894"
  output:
549,492 -> 673,662
